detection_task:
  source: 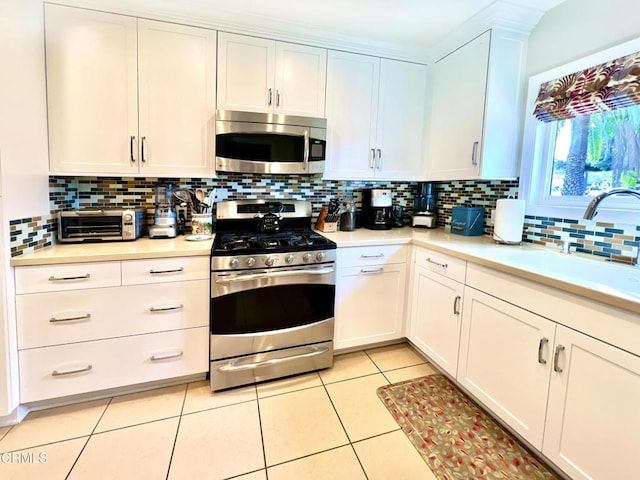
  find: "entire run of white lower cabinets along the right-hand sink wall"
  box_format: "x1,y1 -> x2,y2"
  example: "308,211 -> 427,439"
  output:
408,253 -> 640,480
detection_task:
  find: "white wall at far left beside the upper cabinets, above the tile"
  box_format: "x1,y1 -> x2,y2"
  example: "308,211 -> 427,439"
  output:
0,0 -> 49,221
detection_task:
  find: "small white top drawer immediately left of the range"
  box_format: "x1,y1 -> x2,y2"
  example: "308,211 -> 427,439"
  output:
122,256 -> 210,285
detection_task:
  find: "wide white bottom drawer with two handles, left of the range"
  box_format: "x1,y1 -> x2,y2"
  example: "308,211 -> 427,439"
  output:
19,327 -> 209,403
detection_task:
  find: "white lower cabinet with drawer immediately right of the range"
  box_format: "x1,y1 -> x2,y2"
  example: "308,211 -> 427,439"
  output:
334,245 -> 406,349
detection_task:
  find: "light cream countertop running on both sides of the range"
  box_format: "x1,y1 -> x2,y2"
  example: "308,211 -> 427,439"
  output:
11,227 -> 640,313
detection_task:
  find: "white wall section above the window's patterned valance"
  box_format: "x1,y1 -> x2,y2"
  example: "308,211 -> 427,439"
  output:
527,0 -> 640,77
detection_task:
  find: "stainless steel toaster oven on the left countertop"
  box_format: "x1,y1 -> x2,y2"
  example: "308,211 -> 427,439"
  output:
58,208 -> 144,243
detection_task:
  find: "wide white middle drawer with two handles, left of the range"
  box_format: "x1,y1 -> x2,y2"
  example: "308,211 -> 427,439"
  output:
16,280 -> 209,350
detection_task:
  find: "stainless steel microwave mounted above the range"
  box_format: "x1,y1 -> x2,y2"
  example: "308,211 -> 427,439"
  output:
216,110 -> 327,174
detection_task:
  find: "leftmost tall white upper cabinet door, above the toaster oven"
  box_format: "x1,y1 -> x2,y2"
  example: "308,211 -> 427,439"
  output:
45,4 -> 138,174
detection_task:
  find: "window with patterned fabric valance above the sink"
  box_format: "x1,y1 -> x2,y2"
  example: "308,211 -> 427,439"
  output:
520,41 -> 640,224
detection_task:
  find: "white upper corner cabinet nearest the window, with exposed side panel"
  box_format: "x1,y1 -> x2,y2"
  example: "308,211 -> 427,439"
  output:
426,28 -> 527,180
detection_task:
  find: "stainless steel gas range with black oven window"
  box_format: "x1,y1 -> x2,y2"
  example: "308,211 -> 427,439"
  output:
210,200 -> 336,390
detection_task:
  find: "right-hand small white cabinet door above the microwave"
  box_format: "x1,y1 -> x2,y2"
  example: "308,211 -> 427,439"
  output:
274,42 -> 327,117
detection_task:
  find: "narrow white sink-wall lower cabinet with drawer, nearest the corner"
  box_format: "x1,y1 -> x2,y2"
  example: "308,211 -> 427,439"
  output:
409,248 -> 465,377
